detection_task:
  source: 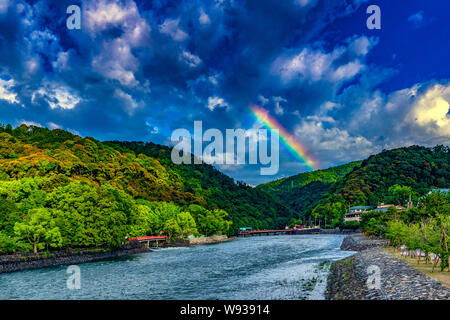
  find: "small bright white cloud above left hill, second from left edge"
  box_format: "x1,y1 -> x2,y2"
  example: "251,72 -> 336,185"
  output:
31,84 -> 82,110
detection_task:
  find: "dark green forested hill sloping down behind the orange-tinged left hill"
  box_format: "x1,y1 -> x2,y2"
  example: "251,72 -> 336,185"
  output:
105,141 -> 296,230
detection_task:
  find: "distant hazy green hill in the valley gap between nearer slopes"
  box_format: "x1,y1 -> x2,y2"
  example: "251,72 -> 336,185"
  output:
257,161 -> 362,216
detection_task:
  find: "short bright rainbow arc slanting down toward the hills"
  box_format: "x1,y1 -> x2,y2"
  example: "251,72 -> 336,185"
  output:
250,105 -> 319,171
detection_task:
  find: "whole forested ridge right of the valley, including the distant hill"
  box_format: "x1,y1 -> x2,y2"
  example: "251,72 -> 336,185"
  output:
264,146 -> 450,227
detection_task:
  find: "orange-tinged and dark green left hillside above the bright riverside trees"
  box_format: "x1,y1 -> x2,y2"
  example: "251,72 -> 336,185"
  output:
0,125 -> 293,240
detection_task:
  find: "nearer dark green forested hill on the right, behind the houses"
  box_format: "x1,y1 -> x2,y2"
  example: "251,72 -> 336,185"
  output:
307,146 -> 450,224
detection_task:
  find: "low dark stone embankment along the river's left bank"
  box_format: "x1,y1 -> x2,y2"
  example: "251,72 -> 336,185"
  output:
0,245 -> 151,273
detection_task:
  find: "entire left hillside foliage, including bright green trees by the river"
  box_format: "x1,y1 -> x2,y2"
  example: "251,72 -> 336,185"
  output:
0,125 -> 291,253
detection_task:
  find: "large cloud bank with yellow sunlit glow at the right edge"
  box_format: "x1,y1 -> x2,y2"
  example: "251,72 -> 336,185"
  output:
339,82 -> 450,149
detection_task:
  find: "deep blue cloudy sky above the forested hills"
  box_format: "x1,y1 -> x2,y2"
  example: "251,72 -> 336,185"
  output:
0,0 -> 450,185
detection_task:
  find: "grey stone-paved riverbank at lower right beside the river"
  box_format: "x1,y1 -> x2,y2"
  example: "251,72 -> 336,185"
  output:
325,235 -> 450,300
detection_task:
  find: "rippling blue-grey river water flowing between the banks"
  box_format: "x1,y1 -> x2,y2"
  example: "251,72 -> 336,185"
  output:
0,235 -> 352,299
